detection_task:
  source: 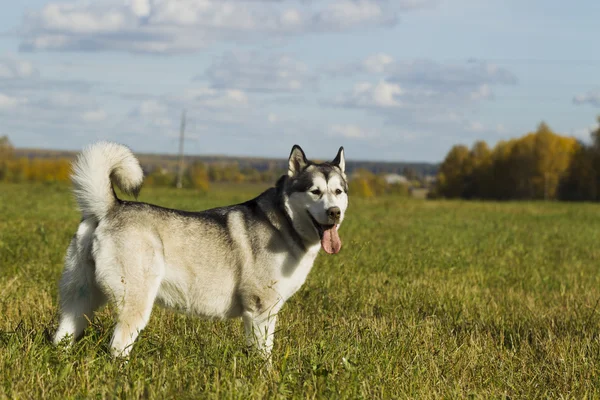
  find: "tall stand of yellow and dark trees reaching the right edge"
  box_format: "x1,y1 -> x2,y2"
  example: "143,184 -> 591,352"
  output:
433,117 -> 600,201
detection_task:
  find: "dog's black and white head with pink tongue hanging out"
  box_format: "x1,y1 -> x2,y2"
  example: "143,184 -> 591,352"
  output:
285,145 -> 348,254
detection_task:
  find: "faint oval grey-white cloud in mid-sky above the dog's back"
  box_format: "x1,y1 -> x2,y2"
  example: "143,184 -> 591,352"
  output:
202,52 -> 316,92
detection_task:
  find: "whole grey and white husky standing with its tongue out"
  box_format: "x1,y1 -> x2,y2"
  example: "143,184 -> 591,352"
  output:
54,142 -> 348,357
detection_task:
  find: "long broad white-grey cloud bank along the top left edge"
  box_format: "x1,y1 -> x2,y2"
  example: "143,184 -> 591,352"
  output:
19,0 -> 436,53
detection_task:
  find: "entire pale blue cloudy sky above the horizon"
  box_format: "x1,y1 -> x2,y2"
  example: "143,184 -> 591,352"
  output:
0,0 -> 600,162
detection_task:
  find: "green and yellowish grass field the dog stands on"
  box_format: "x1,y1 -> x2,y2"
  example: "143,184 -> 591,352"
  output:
0,185 -> 600,399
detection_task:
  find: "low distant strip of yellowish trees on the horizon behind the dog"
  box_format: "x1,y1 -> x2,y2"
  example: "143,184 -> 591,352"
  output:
0,136 -> 432,197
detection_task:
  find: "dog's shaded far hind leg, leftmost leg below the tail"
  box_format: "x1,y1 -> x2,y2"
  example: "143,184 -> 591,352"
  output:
54,221 -> 106,344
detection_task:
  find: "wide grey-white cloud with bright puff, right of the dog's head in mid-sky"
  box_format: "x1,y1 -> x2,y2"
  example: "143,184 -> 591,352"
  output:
328,54 -> 517,133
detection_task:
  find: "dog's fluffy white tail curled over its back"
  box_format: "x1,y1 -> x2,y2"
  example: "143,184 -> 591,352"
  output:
71,142 -> 144,221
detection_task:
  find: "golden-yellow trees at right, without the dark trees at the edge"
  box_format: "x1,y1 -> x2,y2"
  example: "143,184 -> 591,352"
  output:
437,122 -> 584,199
